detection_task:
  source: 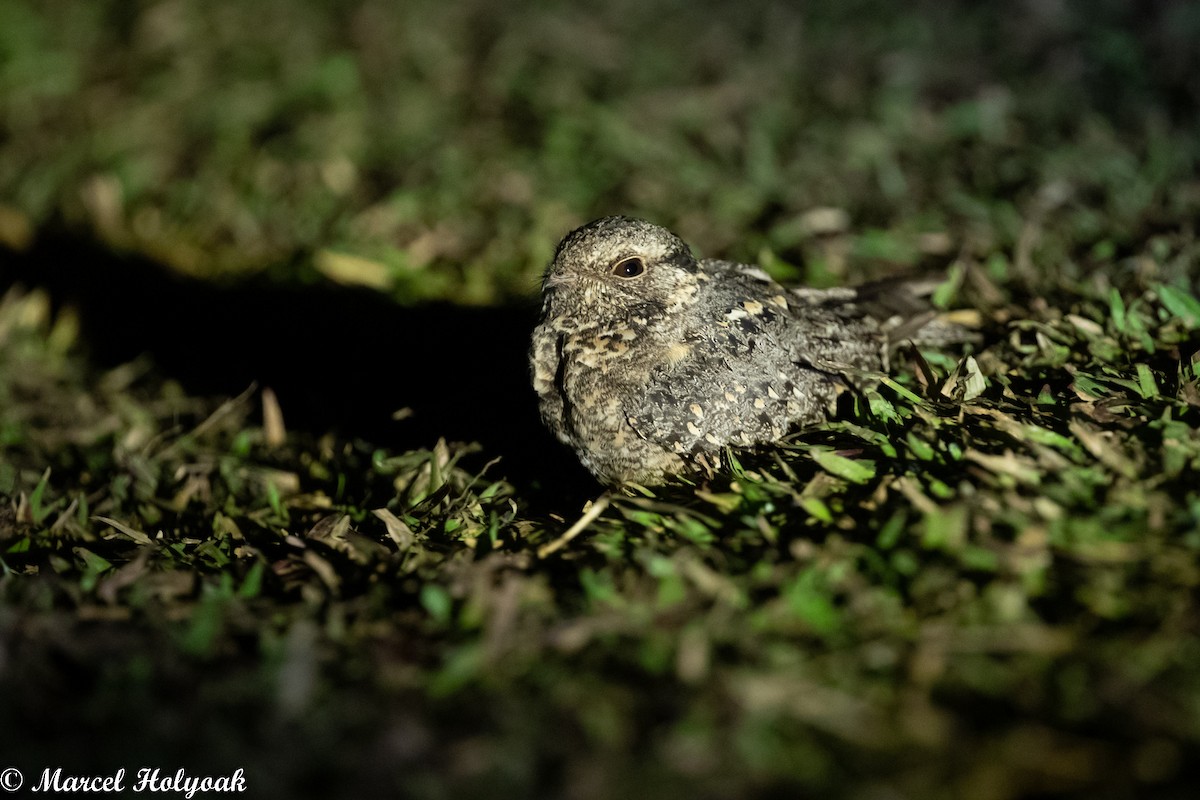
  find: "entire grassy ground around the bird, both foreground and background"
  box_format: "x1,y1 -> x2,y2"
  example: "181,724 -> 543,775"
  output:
0,0 -> 1200,799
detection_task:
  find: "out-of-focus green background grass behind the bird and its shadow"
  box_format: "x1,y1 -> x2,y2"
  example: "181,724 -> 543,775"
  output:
0,0 -> 1200,302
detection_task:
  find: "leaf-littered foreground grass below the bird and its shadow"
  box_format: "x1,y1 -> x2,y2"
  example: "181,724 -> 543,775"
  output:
0,275 -> 1200,798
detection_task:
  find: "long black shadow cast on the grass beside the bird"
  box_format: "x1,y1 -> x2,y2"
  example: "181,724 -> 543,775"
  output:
0,234 -> 600,506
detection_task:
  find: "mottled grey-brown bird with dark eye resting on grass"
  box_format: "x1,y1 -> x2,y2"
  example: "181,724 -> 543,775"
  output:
529,216 -> 953,486
